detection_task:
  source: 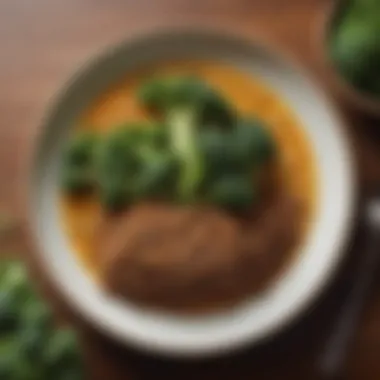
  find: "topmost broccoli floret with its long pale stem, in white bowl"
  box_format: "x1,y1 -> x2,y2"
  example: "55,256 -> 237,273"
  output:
138,76 -> 234,201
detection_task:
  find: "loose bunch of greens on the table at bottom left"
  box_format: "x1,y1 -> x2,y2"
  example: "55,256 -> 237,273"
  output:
0,260 -> 83,380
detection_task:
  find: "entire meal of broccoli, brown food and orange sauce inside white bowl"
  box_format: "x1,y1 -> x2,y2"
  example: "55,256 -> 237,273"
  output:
61,61 -> 315,310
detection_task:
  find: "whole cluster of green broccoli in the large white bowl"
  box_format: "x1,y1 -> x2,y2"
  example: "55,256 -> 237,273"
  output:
63,76 -> 275,211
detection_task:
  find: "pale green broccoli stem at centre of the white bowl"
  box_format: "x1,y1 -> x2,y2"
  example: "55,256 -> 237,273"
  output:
167,108 -> 204,201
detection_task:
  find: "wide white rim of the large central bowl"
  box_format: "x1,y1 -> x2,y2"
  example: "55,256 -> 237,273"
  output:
29,30 -> 354,356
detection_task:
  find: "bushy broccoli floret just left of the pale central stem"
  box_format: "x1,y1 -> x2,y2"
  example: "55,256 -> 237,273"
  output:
97,123 -> 178,211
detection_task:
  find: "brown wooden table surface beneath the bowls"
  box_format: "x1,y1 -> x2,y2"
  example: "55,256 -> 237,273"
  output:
0,0 -> 380,380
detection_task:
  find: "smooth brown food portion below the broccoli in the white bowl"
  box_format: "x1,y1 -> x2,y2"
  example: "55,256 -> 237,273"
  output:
96,197 -> 299,307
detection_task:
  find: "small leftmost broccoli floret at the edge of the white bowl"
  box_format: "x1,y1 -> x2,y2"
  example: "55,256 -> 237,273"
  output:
61,131 -> 97,195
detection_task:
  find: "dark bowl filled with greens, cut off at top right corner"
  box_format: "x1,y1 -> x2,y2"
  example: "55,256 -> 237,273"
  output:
322,0 -> 380,116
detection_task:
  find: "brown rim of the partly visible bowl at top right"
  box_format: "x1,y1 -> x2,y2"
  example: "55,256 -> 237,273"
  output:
317,0 -> 380,119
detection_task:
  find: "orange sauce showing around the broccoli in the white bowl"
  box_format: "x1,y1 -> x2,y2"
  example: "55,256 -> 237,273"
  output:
62,61 -> 316,274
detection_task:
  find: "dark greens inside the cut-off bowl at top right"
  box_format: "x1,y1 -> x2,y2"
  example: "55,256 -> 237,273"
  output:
329,0 -> 380,97
